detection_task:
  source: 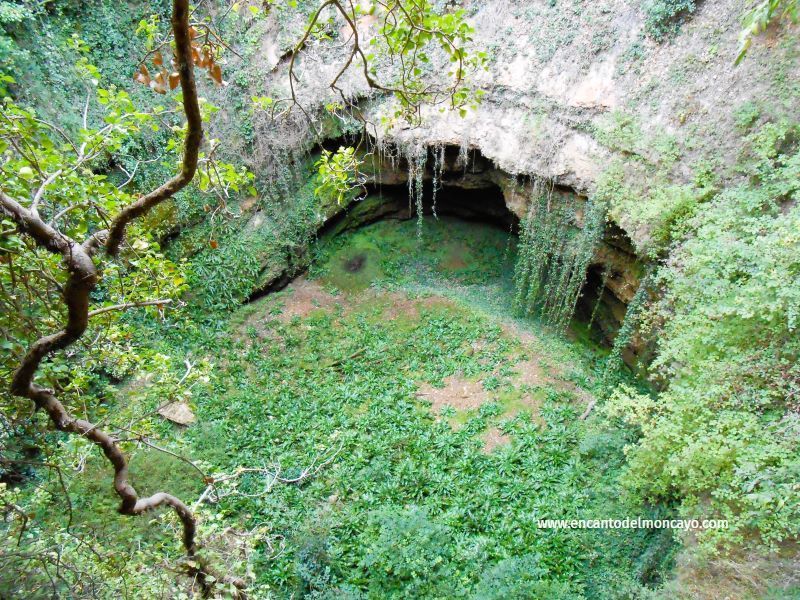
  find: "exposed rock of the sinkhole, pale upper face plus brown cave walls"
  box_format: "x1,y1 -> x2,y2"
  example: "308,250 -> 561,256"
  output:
212,0 -> 800,360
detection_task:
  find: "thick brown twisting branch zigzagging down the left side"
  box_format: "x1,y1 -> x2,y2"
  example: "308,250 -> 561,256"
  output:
0,0 -> 243,591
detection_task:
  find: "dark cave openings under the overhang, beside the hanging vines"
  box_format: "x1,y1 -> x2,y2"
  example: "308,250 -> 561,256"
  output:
262,140 -> 644,356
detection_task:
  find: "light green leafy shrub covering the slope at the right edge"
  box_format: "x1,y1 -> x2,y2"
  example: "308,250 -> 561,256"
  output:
608,123 -> 800,549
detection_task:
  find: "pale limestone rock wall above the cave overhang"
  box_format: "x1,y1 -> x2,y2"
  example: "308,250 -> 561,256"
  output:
220,0 -> 800,220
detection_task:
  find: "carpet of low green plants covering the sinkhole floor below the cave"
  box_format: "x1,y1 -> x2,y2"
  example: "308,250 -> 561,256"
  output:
6,219 -> 672,598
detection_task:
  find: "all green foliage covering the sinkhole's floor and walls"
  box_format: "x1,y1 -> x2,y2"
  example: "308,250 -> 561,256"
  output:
0,0 -> 800,600
